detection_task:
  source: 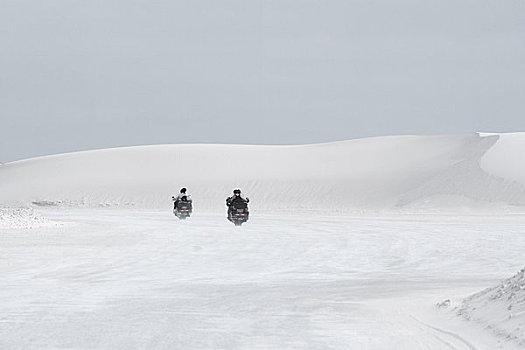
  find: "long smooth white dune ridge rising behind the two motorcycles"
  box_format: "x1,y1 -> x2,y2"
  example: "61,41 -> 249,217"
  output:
0,133 -> 525,212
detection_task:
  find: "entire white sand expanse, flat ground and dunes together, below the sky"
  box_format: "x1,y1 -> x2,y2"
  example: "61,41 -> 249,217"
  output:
0,133 -> 525,350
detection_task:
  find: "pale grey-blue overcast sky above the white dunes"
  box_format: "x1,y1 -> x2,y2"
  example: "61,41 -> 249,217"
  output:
0,0 -> 525,162
